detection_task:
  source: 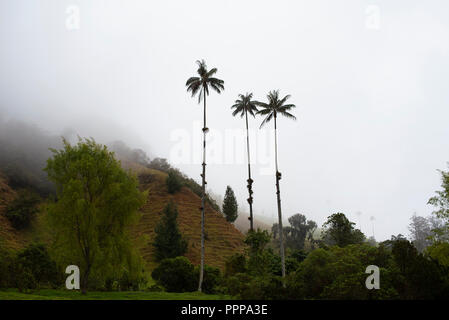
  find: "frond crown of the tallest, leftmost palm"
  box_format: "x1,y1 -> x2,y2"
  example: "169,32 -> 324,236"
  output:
186,60 -> 224,103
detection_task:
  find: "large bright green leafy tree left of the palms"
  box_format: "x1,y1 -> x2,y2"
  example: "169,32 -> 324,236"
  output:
45,139 -> 146,293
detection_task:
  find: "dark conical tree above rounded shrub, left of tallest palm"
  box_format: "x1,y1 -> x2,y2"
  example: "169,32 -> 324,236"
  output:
153,201 -> 187,260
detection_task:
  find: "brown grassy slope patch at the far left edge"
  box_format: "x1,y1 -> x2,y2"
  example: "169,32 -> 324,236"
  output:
0,173 -> 25,249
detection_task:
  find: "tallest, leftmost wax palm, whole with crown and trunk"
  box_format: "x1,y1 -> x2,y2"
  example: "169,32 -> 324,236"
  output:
186,60 -> 224,291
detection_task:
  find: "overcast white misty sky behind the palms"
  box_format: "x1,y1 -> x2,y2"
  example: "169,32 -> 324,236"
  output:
0,0 -> 449,240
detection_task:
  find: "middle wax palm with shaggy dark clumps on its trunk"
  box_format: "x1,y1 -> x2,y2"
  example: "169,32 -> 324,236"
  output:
231,93 -> 258,231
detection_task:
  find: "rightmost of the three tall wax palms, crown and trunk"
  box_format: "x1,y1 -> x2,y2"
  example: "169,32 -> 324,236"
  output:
257,90 -> 296,286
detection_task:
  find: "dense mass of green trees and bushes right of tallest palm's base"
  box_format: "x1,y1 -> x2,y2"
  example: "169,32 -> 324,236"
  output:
215,214 -> 449,300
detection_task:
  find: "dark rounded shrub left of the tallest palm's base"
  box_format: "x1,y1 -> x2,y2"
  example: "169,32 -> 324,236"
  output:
151,257 -> 197,292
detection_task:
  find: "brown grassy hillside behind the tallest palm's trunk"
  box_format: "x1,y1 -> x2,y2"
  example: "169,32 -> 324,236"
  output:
122,161 -> 245,269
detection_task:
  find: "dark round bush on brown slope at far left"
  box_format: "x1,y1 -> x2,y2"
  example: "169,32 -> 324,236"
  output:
6,190 -> 40,230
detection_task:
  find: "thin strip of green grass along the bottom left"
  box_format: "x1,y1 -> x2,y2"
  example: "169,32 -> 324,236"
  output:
0,289 -> 231,300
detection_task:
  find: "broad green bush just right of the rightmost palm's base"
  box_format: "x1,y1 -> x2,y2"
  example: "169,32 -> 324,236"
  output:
287,244 -> 398,300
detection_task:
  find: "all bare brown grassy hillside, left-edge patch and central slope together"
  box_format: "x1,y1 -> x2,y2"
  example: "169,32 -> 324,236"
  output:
0,160 -> 244,270
